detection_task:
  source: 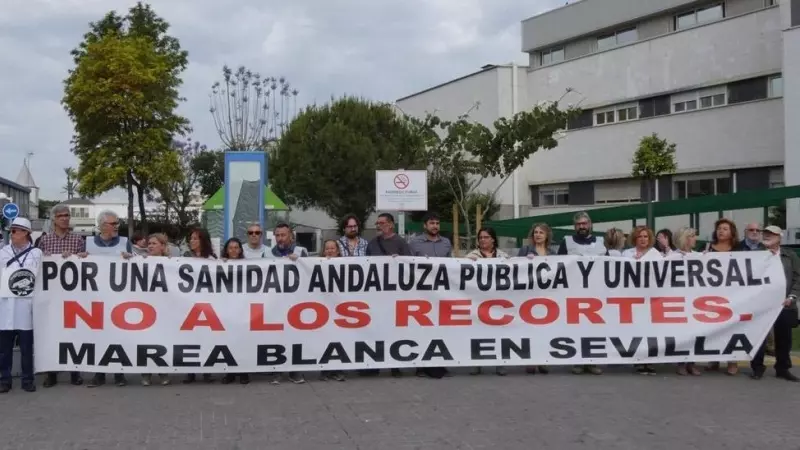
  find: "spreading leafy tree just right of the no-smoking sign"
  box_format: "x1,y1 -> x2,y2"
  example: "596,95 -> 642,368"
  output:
413,102 -> 577,242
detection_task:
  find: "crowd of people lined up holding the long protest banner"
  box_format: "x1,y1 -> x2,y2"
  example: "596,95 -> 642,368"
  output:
0,205 -> 800,393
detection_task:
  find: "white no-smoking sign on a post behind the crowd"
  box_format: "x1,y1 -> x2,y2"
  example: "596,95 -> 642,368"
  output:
375,169 -> 428,236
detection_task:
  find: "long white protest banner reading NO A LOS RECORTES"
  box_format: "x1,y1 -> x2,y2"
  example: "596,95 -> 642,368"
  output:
34,252 -> 785,373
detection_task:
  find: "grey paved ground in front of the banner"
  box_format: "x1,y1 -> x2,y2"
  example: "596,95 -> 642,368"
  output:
0,368 -> 800,450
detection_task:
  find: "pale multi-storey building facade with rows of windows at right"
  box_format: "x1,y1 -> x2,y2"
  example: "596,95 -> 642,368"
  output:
398,0 -> 800,236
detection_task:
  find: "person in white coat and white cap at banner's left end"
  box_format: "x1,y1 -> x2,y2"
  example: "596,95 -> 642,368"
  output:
0,217 -> 42,394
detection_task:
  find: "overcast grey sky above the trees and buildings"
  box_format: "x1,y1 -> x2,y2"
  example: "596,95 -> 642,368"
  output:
0,0 -> 564,199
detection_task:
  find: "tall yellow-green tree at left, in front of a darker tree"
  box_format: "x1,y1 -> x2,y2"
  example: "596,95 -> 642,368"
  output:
63,34 -> 187,237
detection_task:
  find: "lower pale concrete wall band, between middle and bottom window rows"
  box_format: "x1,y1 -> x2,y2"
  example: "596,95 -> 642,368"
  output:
521,98 -> 780,185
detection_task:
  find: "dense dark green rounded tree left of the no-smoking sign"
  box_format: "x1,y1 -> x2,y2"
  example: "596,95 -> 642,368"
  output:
269,97 -> 426,227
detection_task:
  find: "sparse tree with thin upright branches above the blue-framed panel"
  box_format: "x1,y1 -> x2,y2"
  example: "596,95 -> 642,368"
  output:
209,66 -> 299,151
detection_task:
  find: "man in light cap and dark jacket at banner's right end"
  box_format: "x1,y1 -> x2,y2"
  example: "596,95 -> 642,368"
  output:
750,225 -> 800,383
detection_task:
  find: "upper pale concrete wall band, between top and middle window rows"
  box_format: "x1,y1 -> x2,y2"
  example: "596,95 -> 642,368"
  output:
527,7 -> 783,106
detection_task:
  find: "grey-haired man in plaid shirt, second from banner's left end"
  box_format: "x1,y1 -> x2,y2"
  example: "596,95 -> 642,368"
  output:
39,205 -> 86,388
